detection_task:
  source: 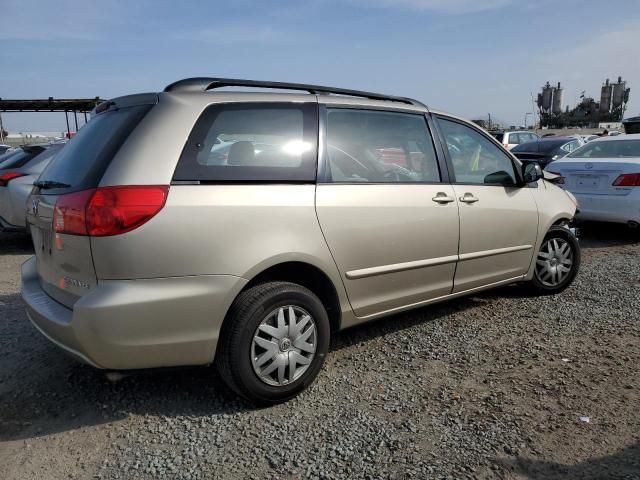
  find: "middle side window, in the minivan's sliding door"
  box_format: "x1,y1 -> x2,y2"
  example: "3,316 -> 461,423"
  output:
327,108 -> 440,183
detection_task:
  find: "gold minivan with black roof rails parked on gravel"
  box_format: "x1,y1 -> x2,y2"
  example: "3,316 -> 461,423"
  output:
22,78 -> 580,404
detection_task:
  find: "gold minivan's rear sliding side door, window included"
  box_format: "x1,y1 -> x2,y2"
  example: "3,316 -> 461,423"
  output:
316,107 -> 459,317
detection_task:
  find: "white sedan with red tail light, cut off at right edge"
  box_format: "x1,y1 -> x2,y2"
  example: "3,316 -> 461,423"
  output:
548,133 -> 640,227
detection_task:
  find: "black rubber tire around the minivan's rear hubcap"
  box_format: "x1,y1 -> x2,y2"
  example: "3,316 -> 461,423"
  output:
216,282 -> 330,405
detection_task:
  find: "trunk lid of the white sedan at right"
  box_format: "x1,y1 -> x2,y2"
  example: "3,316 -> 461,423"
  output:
547,158 -> 640,195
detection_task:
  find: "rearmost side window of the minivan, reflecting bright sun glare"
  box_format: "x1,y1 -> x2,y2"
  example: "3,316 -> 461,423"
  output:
173,103 -> 317,182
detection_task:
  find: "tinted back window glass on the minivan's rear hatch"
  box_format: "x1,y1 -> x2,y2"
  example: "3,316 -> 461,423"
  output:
39,105 -> 152,191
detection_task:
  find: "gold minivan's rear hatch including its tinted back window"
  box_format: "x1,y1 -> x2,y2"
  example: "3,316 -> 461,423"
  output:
27,94 -> 157,308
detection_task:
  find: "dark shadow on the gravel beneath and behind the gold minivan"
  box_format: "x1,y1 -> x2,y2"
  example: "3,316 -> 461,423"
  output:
0,288 -> 481,441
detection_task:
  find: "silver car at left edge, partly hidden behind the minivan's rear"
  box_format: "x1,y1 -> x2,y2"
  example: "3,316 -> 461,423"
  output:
0,144 -> 64,232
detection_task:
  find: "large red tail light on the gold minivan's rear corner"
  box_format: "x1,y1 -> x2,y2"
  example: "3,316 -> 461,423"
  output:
53,185 -> 169,237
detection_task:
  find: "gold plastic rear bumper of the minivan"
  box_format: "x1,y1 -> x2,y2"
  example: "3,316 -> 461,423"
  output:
22,257 -> 246,370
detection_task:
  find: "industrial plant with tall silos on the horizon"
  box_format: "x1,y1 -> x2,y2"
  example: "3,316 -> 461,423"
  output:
537,77 -> 631,128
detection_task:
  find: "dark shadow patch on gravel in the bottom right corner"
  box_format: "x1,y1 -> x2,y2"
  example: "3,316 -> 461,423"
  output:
498,443 -> 640,480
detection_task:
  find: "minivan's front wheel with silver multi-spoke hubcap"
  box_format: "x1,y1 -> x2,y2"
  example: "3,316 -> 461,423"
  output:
530,226 -> 580,295
